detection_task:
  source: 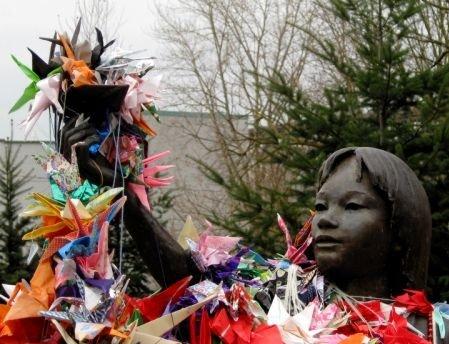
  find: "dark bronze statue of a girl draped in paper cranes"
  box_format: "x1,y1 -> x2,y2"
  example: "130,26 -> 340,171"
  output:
63,124 -> 445,343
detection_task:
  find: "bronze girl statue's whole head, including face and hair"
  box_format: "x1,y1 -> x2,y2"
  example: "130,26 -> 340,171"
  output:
312,147 -> 431,296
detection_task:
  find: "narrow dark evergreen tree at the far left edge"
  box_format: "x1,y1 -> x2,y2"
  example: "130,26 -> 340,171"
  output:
0,127 -> 31,284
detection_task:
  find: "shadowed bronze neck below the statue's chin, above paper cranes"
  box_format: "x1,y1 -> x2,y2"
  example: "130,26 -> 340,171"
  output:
335,276 -> 391,298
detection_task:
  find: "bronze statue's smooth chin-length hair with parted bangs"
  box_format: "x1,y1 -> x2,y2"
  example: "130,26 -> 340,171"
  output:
318,147 -> 432,293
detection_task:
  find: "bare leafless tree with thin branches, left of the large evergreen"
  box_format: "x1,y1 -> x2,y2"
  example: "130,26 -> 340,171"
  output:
152,0 -> 312,224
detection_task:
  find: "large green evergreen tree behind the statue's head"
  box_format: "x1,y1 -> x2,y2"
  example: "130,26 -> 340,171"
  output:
200,0 -> 449,299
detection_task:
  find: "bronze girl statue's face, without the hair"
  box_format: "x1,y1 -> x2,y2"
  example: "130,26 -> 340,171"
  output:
312,157 -> 390,281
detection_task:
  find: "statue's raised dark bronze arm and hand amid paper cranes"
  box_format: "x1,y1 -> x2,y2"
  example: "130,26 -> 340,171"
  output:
61,120 -> 198,287
